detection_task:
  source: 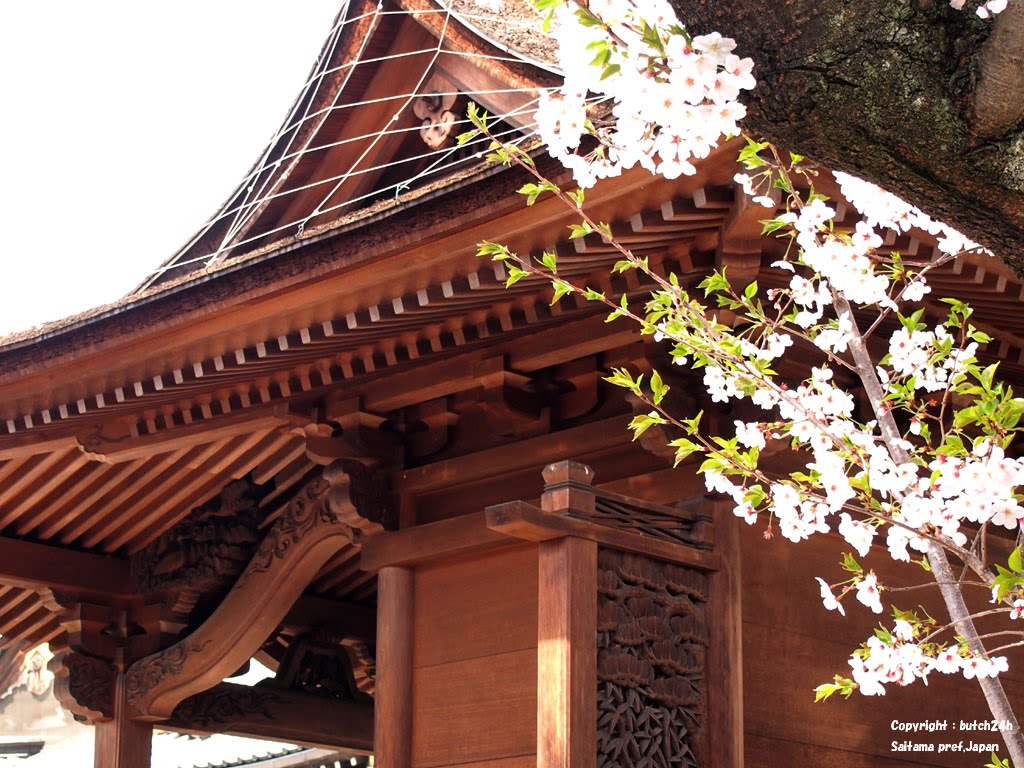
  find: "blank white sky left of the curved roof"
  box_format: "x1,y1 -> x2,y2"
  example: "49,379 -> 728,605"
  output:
0,0 -> 342,334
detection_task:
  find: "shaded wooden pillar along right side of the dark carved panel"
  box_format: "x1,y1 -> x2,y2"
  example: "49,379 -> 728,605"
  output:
708,500 -> 743,768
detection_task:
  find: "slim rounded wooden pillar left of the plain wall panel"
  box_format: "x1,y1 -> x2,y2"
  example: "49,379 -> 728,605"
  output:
374,566 -> 414,768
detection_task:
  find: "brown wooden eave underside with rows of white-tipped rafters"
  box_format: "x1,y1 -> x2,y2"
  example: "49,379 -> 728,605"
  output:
0,156 -> 1024,663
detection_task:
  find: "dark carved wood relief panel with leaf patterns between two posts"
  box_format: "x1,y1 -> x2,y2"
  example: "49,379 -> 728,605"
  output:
597,549 -> 709,768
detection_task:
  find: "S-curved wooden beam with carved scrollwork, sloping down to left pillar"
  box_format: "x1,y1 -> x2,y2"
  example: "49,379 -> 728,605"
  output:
125,463 -> 381,721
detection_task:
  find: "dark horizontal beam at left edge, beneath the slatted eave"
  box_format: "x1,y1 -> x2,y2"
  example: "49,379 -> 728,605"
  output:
0,537 -> 134,598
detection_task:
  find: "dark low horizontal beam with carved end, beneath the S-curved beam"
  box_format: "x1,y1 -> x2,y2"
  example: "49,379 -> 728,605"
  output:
165,683 -> 374,753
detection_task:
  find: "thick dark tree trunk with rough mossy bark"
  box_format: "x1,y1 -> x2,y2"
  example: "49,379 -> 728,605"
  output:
672,0 -> 1024,274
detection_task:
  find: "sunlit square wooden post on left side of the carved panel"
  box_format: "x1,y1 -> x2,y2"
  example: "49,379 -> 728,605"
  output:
537,537 -> 597,768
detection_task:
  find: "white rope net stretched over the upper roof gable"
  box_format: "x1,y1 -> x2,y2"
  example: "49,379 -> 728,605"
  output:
139,0 -> 557,290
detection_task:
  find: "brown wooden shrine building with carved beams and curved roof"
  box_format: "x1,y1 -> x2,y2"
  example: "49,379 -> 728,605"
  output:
0,0 -> 1024,768
